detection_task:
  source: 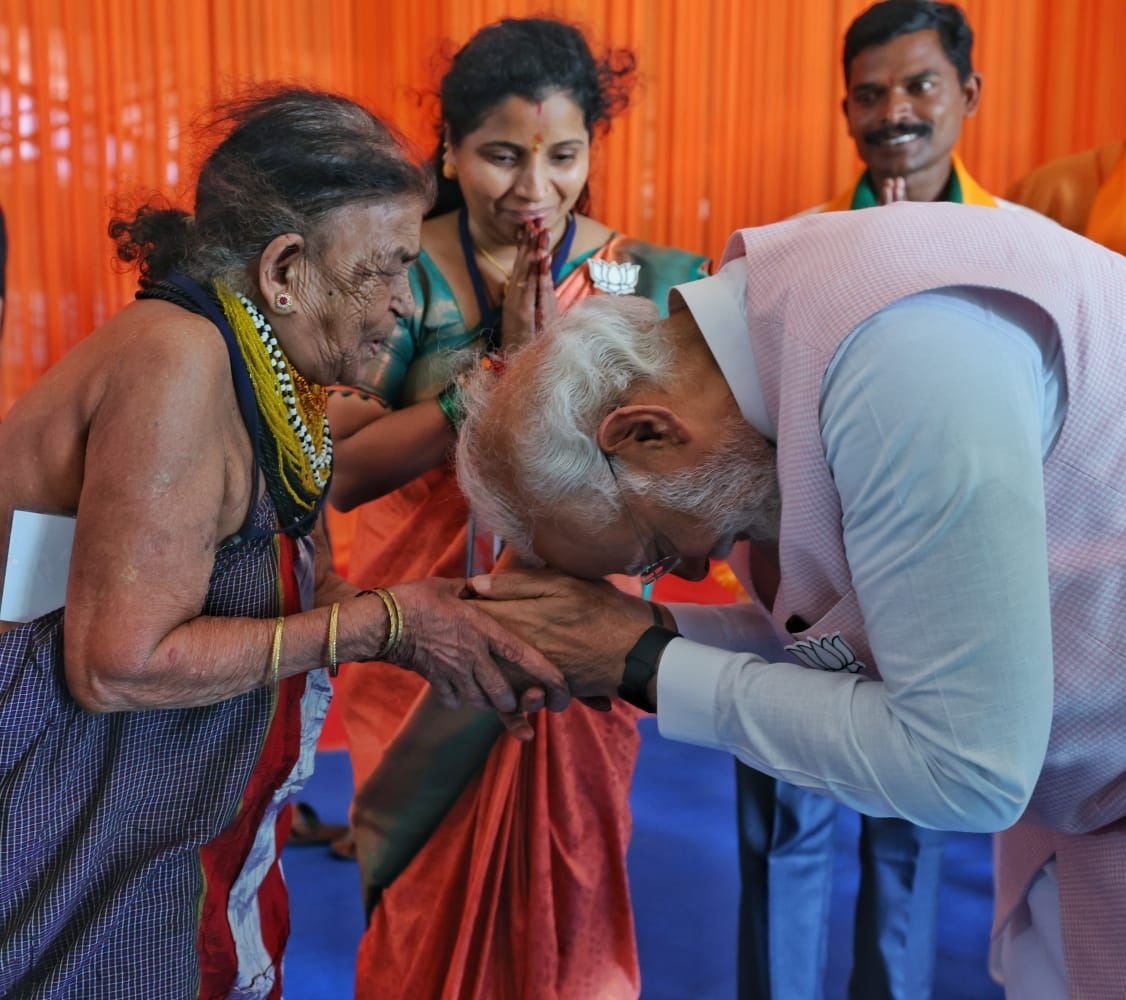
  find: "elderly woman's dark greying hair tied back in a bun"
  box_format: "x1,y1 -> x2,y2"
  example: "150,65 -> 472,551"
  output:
109,88 -> 434,292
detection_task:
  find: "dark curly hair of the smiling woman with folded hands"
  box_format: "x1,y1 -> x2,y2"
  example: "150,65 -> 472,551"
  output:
430,17 -> 637,215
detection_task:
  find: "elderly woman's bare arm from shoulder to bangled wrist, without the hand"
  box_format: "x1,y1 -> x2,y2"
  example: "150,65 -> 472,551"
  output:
57,319 -> 386,712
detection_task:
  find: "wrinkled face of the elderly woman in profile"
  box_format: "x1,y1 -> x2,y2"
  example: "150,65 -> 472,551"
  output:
287,197 -> 426,385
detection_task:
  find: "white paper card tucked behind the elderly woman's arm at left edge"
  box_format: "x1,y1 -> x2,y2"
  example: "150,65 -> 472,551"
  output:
0,510 -> 74,622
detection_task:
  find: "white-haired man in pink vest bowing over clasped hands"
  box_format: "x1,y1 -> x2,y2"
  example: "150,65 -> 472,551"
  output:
458,203 -> 1126,1000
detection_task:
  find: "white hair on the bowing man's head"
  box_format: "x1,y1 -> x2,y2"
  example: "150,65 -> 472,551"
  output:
457,296 -> 672,559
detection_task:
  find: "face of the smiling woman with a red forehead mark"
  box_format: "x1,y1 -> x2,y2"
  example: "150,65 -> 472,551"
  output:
448,91 -> 590,245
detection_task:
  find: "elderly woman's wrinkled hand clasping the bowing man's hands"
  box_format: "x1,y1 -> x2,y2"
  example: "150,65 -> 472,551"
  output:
382,579 -> 571,729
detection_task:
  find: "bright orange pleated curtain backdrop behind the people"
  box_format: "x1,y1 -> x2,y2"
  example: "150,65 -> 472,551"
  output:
0,0 -> 1126,412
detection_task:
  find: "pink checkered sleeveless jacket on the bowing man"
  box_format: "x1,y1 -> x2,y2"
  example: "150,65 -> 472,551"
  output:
724,203 -> 1126,1000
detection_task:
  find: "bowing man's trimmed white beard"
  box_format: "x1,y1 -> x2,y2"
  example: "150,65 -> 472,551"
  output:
622,417 -> 781,552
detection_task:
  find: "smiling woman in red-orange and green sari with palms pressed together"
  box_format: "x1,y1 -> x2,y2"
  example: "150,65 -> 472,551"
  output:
330,18 -> 706,1000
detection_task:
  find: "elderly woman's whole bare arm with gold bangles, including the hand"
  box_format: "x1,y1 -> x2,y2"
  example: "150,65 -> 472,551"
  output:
54,328 -> 568,712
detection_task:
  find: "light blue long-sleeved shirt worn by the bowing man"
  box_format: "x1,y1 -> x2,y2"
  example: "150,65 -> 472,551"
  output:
658,261 -> 1066,830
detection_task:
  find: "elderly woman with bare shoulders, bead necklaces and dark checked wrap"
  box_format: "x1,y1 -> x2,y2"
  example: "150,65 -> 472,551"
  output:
0,90 -> 566,1000
